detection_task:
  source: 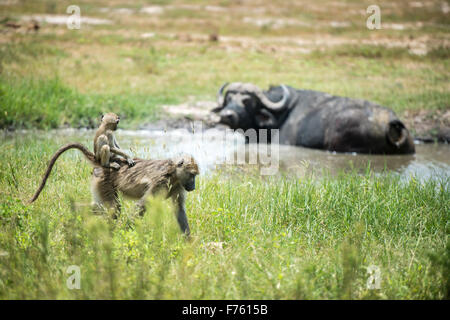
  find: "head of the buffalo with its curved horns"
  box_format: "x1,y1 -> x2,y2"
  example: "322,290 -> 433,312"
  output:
212,82 -> 289,130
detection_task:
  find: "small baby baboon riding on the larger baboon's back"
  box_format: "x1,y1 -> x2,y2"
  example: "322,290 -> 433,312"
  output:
94,113 -> 134,170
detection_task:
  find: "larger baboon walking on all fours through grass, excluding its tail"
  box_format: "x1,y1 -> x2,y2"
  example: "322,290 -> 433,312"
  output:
92,155 -> 199,235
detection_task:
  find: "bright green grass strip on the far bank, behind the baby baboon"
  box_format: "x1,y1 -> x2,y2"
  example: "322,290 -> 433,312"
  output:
0,78 -> 176,129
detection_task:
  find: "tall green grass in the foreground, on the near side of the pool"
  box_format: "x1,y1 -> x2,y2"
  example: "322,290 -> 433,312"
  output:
0,137 -> 450,299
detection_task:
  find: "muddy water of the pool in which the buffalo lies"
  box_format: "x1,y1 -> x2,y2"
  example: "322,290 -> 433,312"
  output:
4,129 -> 450,180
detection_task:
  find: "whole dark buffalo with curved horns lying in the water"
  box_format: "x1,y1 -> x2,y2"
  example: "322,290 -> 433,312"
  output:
212,82 -> 415,154
